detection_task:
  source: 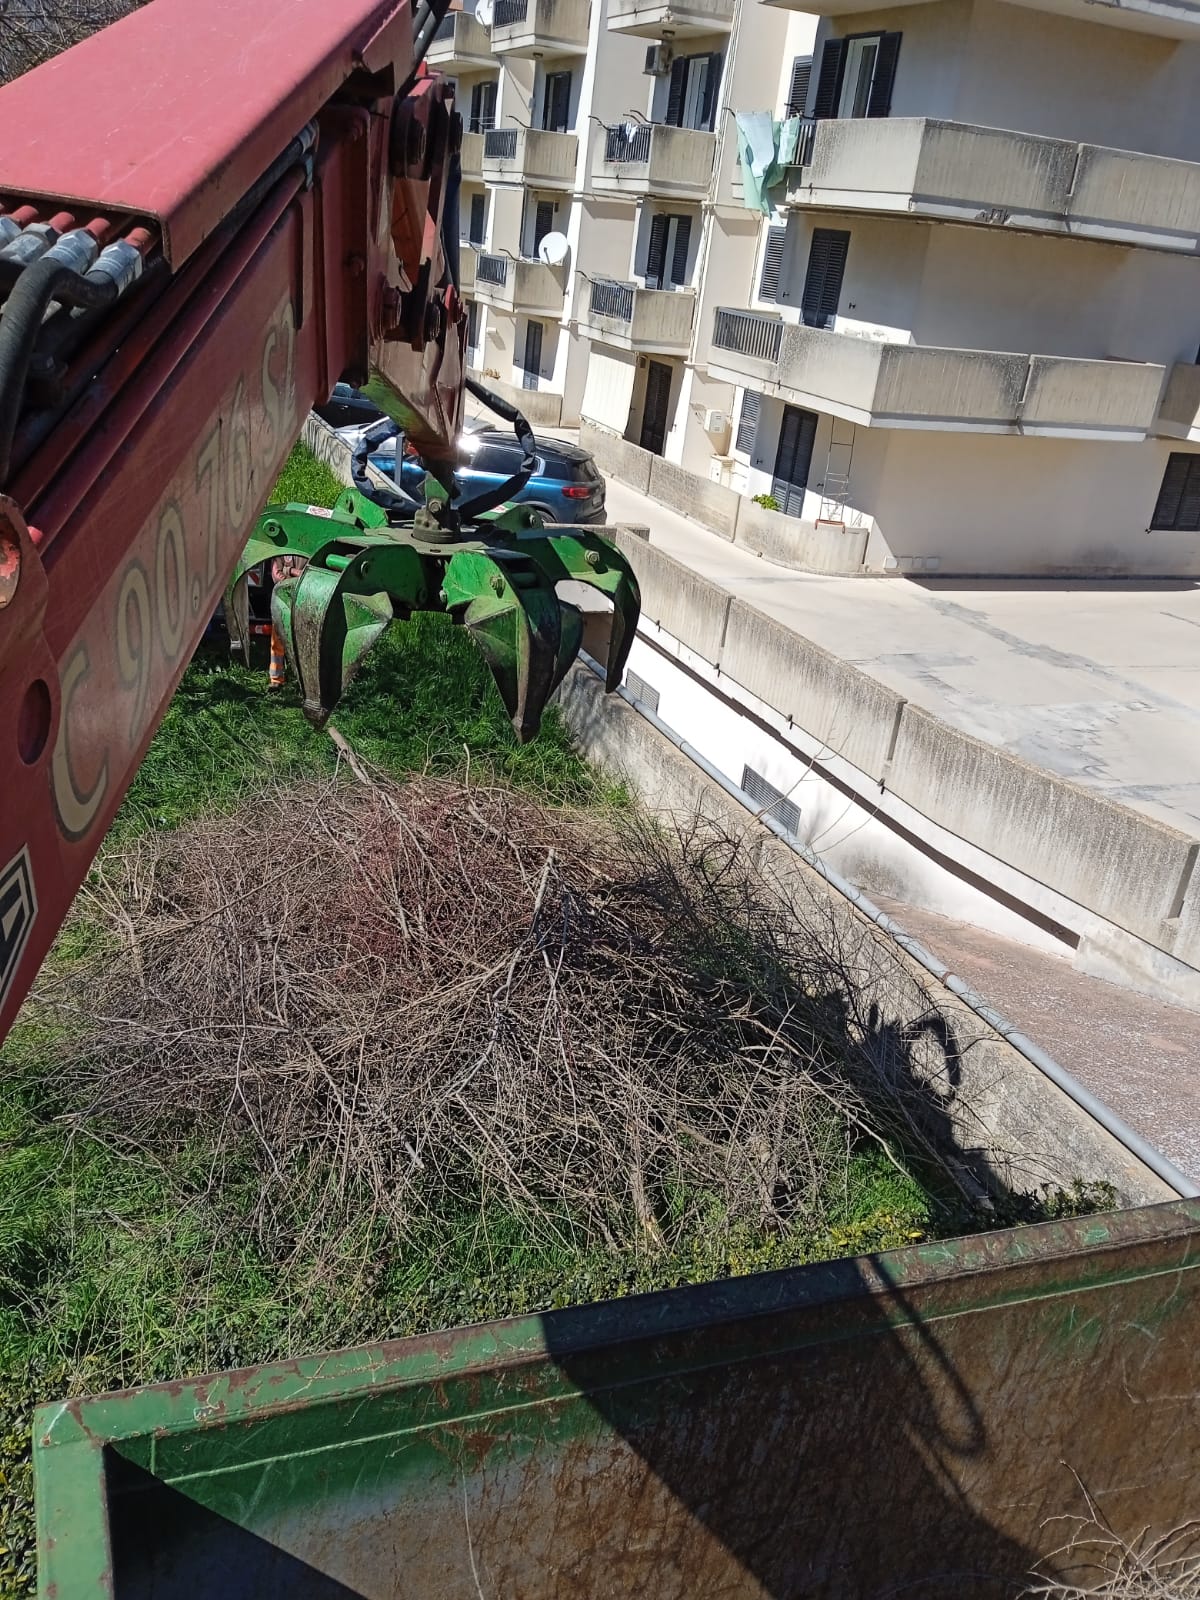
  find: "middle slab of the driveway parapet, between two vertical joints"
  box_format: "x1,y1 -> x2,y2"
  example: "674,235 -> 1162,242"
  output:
720,600 -> 904,778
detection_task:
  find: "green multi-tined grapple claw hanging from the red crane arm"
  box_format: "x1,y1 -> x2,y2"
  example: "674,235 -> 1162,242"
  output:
240,490 -> 640,744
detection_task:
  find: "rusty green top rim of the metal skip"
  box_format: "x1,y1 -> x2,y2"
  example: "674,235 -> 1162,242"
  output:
34,1200 -> 1200,1504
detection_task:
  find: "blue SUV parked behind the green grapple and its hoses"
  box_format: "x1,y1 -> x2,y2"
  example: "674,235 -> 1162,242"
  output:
370,427 -> 605,523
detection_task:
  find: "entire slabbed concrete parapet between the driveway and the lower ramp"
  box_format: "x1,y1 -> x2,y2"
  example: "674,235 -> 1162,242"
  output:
611,541 -> 1200,992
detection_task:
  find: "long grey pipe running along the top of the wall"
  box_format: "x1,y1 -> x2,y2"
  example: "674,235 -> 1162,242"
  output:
579,651 -> 1200,1200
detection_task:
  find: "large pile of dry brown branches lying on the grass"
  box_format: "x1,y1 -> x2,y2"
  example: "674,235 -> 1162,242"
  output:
42,779 -> 979,1250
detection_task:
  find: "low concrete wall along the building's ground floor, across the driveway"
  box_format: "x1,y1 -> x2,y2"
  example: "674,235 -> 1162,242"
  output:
579,421 -> 867,578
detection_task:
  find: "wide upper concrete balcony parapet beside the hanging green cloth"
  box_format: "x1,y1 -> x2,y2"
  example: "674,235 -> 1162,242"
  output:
787,117 -> 1200,253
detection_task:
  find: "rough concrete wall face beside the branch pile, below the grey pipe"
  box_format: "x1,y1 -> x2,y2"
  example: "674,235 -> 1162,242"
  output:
560,666 -> 1173,1205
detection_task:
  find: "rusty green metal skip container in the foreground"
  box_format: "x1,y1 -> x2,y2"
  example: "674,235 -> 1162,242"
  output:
35,1202 -> 1200,1600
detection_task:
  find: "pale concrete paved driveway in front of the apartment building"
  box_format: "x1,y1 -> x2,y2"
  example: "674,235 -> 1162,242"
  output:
608,480 -> 1200,837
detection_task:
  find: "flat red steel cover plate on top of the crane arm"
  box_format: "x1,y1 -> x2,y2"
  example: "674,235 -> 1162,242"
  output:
0,0 -> 413,267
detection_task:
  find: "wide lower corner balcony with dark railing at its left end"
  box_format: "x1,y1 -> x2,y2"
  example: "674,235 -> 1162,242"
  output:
707,307 -> 1163,440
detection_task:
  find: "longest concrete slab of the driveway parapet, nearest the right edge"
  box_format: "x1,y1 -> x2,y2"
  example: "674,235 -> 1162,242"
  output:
888,702 -> 1195,950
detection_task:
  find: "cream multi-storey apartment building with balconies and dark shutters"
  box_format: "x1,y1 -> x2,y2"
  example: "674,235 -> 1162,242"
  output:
448,0 -> 1200,574
